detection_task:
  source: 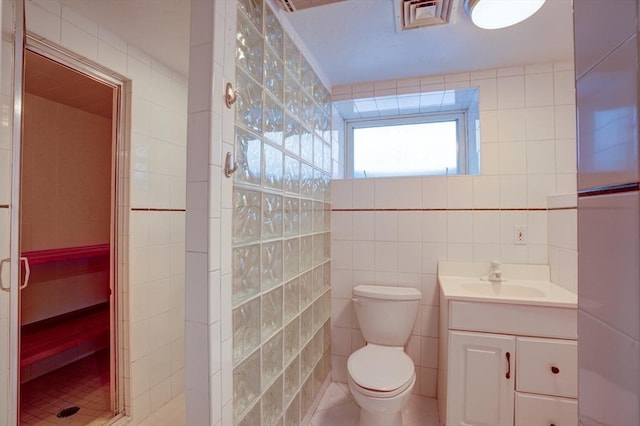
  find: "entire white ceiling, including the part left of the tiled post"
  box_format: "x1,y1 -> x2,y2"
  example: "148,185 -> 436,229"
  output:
56,0 -> 573,86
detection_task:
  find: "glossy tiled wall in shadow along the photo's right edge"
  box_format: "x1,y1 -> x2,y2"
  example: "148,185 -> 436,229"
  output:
565,5 -> 640,420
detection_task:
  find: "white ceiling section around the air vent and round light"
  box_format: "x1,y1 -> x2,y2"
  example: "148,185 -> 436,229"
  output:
288,0 -> 573,85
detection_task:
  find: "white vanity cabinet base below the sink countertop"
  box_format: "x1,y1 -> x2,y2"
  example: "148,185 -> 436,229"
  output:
439,300 -> 578,426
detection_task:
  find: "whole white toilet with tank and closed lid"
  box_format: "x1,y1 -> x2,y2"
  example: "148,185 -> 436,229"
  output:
347,285 -> 422,426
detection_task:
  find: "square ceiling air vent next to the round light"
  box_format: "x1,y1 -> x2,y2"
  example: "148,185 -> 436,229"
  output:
395,0 -> 458,30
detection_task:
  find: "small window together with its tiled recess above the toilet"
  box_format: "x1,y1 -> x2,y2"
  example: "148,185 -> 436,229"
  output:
333,87 -> 481,178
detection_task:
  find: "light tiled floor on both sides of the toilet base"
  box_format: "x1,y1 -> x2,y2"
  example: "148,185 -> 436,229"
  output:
309,382 -> 439,426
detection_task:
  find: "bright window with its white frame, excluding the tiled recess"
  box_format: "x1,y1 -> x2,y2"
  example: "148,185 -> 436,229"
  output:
346,110 -> 468,178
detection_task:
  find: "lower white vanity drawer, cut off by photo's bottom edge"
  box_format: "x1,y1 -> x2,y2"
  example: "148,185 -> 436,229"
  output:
515,393 -> 578,426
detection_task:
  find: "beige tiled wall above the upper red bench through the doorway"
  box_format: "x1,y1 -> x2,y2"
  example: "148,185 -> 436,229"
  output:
20,93 -> 112,252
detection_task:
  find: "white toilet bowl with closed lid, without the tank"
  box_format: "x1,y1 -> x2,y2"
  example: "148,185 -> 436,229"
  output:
347,344 -> 416,426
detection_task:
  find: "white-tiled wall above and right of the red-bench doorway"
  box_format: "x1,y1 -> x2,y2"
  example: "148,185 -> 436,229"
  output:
26,0 -> 187,421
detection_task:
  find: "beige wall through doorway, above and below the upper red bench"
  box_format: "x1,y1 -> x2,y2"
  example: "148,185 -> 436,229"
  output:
20,93 -> 112,324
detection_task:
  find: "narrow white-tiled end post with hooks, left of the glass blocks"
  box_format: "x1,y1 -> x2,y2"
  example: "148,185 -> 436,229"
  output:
186,1 -> 236,425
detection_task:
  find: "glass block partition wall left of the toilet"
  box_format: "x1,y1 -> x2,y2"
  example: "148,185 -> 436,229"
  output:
232,0 -> 332,426
